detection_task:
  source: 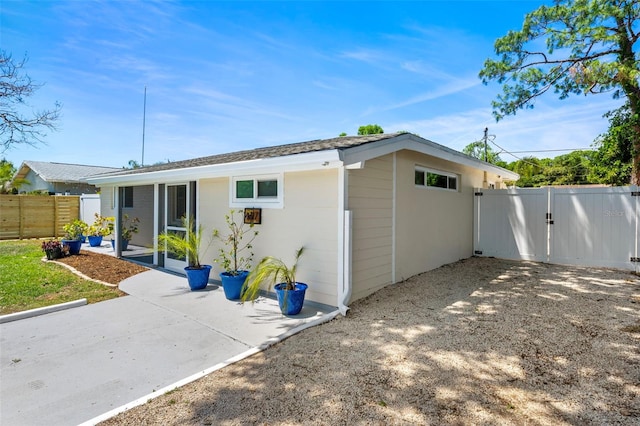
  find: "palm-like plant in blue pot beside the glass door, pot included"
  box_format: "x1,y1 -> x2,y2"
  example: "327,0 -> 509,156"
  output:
158,217 -> 211,290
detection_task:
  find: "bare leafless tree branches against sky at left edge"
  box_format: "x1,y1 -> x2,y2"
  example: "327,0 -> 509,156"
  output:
0,50 -> 60,152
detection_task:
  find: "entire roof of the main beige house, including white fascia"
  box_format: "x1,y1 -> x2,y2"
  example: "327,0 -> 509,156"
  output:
89,133 -> 519,184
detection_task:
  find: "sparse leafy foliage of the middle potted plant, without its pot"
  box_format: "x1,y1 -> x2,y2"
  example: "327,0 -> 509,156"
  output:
213,210 -> 258,276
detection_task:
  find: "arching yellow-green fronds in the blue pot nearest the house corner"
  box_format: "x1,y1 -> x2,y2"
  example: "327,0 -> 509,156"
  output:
242,247 -> 304,301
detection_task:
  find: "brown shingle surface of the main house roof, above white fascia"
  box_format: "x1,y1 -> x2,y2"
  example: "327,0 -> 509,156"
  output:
99,133 -> 401,175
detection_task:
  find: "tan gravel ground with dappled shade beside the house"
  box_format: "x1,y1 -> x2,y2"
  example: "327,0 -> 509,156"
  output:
104,258 -> 640,426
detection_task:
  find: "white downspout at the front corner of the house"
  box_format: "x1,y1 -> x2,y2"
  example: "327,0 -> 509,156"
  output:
337,166 -> 352,316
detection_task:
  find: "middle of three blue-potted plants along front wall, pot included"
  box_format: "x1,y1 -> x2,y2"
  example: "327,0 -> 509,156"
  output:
213,210 -> 258,300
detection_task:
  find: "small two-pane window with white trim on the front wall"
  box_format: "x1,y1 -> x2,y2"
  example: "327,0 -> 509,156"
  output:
231,175 -> 283,207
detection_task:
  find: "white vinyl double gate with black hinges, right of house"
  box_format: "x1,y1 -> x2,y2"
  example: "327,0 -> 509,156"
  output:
473,186 -> 640,271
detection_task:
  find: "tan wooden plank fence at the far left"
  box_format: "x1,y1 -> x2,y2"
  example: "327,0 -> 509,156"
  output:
0,195 -> 80,240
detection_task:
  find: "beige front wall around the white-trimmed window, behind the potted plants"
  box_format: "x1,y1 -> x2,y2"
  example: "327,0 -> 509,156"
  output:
198,170 -> 338,306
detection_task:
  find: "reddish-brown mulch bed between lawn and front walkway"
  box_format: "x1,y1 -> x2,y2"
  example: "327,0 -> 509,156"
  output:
57,250 -> 148,284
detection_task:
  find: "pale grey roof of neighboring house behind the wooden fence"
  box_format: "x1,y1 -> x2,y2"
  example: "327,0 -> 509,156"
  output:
13,161 -> 122,183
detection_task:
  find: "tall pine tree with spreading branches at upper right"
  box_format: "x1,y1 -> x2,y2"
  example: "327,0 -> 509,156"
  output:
480,0 -> 640,182
